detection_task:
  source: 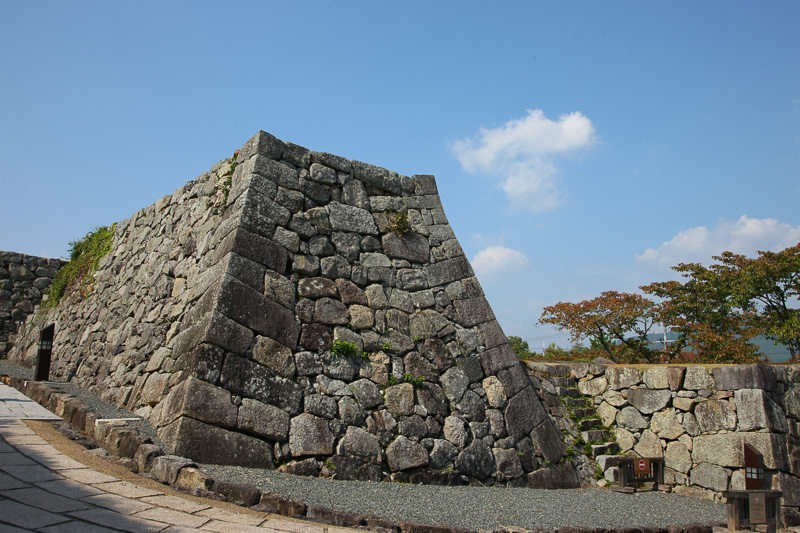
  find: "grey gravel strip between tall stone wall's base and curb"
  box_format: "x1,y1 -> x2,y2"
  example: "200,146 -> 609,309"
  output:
0,360 -> 726,529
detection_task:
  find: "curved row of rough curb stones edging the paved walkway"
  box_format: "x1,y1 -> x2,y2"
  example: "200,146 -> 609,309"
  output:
0,375 -> 727,533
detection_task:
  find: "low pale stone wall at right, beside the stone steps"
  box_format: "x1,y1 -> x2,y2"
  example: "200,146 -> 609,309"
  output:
528,363 -> 800,524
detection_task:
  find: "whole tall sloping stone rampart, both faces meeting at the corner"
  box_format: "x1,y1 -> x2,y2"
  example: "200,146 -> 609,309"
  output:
10,132 -> 579,486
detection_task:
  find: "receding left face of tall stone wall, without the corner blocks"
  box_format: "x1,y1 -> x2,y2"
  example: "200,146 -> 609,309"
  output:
9,156 -> 230,392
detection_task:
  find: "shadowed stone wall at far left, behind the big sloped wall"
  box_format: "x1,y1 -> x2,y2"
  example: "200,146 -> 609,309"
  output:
0,251 -> 64,359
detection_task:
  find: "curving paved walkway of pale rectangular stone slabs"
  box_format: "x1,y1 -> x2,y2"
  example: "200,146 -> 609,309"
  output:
0,384 -> 362,533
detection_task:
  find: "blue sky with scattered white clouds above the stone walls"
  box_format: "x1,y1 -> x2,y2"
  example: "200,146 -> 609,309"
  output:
0,0 -> 800,348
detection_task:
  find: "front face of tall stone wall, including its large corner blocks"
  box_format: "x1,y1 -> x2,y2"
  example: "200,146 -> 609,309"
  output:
156,132 -> 577,484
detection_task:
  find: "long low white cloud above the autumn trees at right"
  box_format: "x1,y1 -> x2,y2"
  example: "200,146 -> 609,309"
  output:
636,215 -> 800,269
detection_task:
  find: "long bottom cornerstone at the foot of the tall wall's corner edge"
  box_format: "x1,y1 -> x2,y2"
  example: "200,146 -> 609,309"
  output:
158,416 -> 273,469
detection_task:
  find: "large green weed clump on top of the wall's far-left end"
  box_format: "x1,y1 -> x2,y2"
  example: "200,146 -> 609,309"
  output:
43,223 -> 117,309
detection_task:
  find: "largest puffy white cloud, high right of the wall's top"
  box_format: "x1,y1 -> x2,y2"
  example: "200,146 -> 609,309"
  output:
451,109 -> 597,212
